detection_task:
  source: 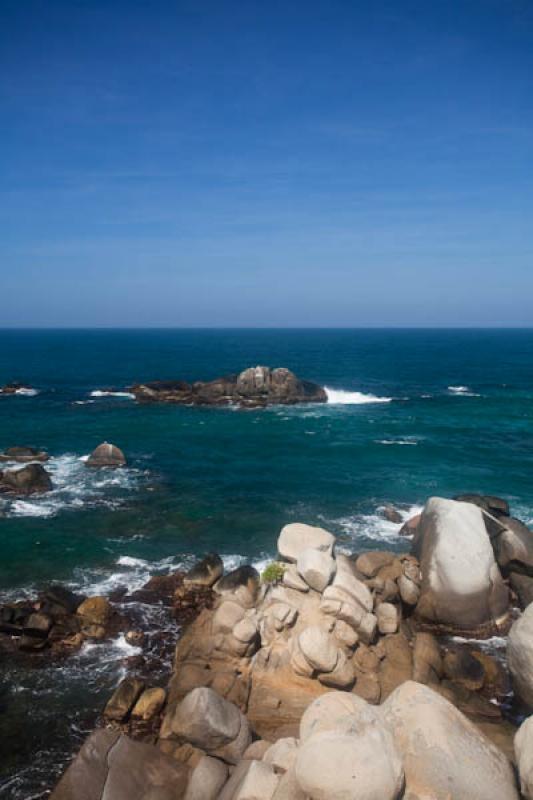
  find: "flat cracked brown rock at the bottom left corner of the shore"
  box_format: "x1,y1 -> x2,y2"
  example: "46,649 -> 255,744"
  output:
50,730 -> 190,800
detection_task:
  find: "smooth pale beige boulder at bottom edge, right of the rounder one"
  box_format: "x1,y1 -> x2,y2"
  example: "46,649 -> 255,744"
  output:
380,681 -> 518,800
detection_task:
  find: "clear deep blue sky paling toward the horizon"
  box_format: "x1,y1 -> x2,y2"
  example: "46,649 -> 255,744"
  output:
0,0 -> 533,327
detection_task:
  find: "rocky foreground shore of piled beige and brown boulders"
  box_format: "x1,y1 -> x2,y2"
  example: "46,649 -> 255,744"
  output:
12,496 -> 533,800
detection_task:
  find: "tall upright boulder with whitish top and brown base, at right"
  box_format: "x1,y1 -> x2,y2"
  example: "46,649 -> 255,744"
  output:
413,497 -> 509,633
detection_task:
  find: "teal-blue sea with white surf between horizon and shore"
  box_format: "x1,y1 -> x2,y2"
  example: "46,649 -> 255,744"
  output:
0,330 -> 533,800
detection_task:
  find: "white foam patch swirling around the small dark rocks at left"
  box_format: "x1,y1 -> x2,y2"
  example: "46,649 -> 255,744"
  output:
0,453 -> 143,517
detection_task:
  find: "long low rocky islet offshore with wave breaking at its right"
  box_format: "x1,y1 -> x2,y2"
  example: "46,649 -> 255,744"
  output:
128,367 -> 327,408
